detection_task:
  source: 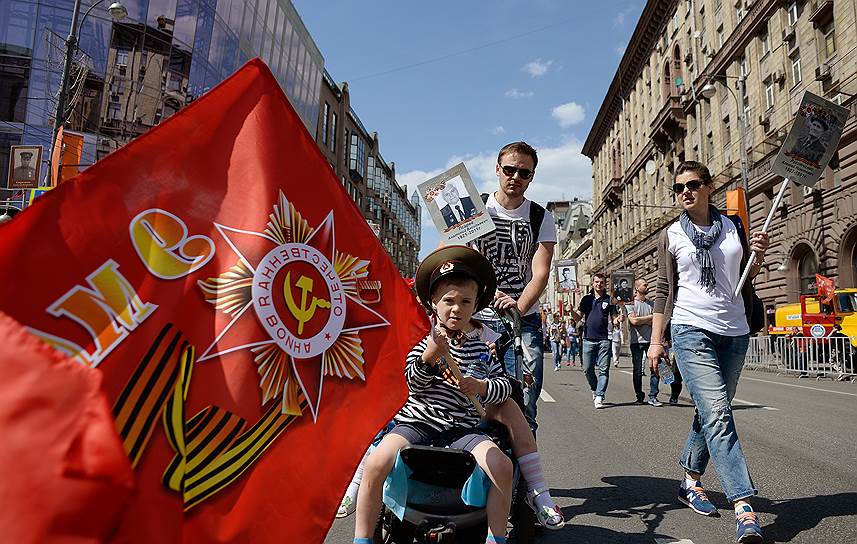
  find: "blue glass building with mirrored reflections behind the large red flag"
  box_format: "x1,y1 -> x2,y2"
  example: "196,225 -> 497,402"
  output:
0,0 -> 324,184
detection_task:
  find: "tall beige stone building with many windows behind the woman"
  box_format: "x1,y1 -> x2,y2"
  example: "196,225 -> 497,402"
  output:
583,0 -> 857,318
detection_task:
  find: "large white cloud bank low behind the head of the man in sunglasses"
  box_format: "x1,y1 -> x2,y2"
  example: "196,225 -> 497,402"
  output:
396,140 -> 592,258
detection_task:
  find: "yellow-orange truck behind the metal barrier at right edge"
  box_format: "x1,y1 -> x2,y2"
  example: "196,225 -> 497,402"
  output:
768,288 -> 857,346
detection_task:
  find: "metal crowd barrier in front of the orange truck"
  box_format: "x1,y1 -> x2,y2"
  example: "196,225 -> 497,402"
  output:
744,336 -> 857,379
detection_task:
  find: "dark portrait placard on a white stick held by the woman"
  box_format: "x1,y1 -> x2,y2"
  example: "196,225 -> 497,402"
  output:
771,91 -> 848,187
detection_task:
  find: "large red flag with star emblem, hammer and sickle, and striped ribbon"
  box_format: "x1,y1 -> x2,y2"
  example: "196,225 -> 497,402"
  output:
0,60 -> 428,543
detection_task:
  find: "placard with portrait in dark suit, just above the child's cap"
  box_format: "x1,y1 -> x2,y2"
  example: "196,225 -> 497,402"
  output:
417,163 -> 495,244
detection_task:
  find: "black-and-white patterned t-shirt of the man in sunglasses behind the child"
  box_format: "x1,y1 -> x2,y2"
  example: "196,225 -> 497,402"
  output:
473,194 -> 556,315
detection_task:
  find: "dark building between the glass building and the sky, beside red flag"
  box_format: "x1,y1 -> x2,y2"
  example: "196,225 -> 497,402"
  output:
316,70 -> 420,277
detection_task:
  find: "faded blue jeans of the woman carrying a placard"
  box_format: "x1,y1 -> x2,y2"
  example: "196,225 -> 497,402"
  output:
672,325 -> 757,502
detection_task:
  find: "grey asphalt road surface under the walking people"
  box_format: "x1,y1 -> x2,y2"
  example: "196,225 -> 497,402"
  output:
325,355 -> 857,544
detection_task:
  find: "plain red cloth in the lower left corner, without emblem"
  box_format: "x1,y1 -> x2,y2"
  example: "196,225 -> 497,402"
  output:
0,313 -> 133,542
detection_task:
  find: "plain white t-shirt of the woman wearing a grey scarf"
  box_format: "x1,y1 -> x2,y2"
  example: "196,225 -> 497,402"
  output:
667,216 -> 750,336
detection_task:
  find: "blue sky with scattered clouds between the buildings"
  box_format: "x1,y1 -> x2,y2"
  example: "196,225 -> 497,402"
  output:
293,0 -> 645,258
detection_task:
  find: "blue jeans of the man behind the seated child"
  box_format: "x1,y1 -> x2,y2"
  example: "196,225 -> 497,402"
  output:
489,312 -> 545,433
